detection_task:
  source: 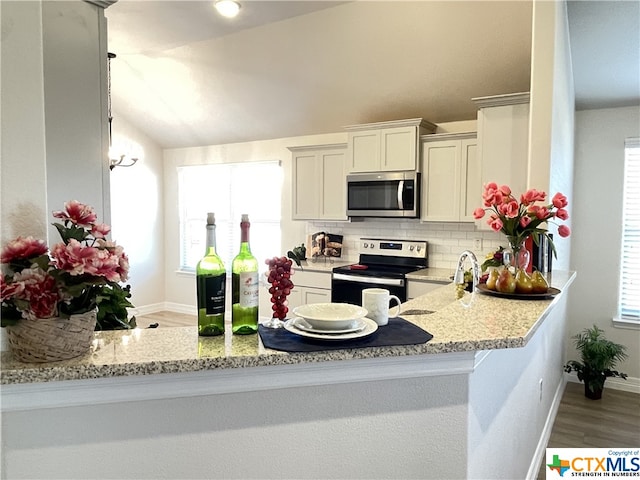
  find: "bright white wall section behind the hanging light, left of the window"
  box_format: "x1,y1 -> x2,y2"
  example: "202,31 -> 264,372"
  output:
110,116 -> 165,313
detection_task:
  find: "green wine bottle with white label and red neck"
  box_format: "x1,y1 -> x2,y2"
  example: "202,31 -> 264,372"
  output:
231,214 -> 258,335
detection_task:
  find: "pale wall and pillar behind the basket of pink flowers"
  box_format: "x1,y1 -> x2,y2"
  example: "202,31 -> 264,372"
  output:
1,1 -> 110,242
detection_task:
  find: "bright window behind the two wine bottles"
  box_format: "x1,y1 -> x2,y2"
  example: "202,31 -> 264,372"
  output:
178,161 -> 283,275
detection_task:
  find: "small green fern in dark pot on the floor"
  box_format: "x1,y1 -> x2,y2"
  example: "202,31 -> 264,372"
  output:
564,325 -> 627,400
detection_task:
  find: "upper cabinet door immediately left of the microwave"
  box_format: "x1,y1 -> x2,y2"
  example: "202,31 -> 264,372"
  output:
318,150 -> 347,220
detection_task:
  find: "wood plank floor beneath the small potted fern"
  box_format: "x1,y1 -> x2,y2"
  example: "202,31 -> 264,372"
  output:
538,382 -> 640,480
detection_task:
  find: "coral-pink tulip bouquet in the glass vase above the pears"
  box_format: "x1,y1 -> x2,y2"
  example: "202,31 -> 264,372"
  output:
473,182 -> 571,255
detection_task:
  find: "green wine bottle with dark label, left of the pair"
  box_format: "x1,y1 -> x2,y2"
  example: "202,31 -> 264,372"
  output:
196,213 -> 227,336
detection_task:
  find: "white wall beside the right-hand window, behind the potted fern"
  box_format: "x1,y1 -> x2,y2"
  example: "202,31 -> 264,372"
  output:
567,107 -> 640,382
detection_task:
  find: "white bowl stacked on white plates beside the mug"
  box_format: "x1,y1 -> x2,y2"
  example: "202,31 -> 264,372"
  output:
284,303 -> 378,340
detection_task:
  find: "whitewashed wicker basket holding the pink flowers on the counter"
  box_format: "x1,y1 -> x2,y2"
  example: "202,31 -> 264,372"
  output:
6,310 -> 97,362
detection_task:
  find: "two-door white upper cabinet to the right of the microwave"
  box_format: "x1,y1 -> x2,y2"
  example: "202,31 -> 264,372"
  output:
420,132 -> 482,222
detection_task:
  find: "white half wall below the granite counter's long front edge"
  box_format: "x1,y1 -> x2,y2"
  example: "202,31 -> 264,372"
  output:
2,376 -> 470,480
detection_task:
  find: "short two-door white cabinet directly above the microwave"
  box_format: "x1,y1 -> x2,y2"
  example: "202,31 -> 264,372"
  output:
345,118 -> 436,173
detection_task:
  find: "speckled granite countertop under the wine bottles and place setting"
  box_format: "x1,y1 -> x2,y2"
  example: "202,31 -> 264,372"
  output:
0,272 -> 575,384
